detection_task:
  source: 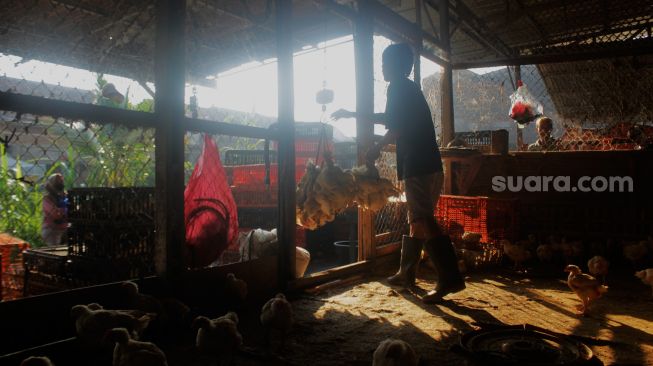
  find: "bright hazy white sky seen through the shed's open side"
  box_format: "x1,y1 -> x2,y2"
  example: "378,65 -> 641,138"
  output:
0,36 -> 497,136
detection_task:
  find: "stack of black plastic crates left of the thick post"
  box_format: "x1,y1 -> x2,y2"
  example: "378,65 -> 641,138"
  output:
68,187 -> 155,282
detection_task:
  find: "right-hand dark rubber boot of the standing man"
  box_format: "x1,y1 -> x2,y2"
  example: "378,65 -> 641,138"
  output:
422,235 -> 465,304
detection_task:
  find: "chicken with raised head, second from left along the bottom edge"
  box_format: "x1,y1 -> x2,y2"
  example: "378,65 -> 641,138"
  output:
106,328 -> 168,366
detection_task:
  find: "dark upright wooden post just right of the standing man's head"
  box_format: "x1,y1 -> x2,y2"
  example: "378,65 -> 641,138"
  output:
438,0 -> 455,146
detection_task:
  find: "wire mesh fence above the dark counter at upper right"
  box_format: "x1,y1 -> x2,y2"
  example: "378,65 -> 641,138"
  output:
424,57 -> 653,151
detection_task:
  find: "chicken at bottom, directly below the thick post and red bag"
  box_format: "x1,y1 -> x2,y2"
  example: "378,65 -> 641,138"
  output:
193,312 -> 243,364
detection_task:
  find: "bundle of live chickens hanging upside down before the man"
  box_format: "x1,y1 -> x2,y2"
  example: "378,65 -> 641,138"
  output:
297,152 -> 400,230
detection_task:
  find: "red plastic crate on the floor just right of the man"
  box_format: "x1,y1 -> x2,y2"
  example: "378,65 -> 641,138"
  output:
435,195 -> 519,243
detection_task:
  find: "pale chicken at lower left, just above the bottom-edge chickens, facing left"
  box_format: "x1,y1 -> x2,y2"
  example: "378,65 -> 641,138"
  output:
70,303 -> 156,349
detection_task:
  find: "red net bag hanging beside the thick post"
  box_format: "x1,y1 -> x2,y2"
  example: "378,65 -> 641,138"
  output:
184,134 -> 238,267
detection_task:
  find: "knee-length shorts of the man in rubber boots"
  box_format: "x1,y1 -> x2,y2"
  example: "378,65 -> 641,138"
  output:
404,172 -> 444,223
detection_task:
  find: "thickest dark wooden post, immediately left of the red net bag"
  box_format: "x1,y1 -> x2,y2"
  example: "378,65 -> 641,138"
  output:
154,0 -> 187,278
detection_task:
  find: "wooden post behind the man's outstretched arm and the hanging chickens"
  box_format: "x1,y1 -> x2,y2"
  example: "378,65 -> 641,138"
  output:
354,0 -> 375,260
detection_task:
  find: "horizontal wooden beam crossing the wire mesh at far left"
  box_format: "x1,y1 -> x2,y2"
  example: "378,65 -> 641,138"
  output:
0,92 -> 158,128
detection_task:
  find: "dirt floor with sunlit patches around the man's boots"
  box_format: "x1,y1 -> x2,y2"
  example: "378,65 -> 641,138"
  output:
239,269 -> 653,366
